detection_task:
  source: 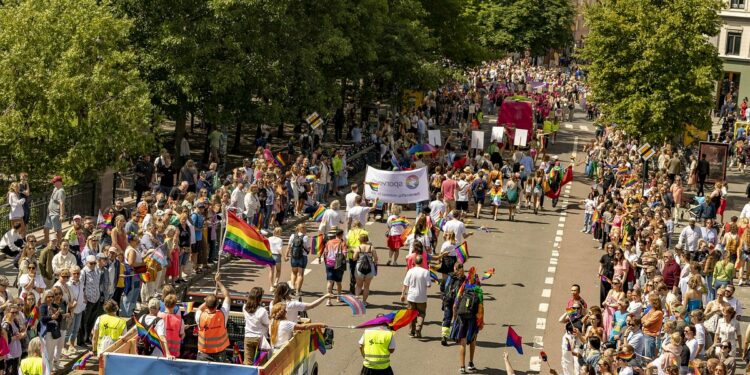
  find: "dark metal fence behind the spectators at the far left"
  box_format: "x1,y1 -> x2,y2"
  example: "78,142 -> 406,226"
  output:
0,182 -> 98,233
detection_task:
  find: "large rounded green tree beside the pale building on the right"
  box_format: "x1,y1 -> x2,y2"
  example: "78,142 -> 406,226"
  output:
581,0 -> 721,140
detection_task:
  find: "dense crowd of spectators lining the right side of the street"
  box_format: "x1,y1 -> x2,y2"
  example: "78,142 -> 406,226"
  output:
559,112 -> 750,375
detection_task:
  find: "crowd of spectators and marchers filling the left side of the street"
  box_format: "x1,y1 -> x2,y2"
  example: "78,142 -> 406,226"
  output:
0,59 -> 604,374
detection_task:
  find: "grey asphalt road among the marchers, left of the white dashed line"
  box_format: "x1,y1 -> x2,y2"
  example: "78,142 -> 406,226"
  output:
189,113 -> 580,374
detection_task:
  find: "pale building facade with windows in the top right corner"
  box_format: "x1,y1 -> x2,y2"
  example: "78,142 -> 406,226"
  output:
711,0 -> 750,111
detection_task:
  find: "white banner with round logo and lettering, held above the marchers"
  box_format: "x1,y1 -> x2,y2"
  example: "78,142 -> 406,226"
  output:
365,165 -> 430,204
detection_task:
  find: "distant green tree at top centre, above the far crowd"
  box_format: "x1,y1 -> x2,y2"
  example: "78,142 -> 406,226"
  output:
465,0 -> 575,56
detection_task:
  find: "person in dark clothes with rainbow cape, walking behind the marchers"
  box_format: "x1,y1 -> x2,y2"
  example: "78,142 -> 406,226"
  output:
450,267 -> 484,374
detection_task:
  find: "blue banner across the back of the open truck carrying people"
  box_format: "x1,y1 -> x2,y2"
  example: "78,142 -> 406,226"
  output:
104,354 -> 258,375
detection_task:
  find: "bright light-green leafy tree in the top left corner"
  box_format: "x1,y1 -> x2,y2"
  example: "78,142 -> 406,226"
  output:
0,0 -> 153,181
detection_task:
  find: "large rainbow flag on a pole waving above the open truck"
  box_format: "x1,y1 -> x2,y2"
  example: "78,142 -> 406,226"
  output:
223,211 -> 276,266
